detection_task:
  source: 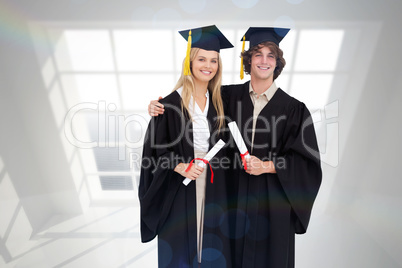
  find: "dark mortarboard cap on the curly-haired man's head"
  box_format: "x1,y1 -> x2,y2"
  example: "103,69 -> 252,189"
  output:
241,27 -> 290,48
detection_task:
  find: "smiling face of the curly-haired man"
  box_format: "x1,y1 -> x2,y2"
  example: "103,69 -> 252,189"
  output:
250,47 -> 276,83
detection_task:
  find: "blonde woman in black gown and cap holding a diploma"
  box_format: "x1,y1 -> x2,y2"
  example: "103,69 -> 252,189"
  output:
139,26 -> 233,267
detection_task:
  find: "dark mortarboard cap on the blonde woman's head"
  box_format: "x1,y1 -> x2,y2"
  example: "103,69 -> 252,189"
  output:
179,25 -> 233,52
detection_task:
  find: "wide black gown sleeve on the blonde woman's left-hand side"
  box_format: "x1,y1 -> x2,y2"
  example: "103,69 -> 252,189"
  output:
138,111 -> 182,242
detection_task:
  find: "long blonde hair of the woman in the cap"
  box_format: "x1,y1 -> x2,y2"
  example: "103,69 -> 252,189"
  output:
173,47 -> 225,131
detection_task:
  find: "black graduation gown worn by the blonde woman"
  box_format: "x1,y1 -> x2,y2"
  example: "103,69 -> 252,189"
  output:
139,91 -> 231,268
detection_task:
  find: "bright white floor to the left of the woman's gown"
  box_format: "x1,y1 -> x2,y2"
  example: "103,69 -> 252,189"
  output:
0,207 -> 157,268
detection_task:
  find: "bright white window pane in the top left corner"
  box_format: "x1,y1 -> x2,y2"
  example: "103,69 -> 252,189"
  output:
63,30 -> 114,72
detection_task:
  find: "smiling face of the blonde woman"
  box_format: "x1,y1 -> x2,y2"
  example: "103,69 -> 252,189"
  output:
191,49 -> 219,83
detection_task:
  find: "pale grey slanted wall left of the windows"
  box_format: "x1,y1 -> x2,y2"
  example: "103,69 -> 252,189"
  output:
0,17 -> 82,256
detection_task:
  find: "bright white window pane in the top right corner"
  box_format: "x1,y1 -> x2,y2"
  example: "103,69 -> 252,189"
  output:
295,30 -> 344,72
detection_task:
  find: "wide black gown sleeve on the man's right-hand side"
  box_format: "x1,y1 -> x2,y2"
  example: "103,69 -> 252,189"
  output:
275,103 -> 322,234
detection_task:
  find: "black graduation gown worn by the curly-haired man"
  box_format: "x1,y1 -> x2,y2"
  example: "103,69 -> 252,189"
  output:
222,82 -> 322,268
